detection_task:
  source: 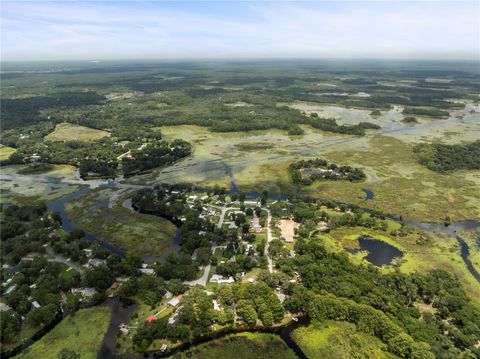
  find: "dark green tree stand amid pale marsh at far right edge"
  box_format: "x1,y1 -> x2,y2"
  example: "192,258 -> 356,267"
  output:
413,140 -> 480,173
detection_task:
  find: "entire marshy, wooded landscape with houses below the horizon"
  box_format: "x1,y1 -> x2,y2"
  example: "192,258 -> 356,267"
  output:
0,61 -> 480,359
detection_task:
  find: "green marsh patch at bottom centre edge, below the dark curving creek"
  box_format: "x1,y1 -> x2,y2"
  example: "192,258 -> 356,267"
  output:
173,333 -> 296,359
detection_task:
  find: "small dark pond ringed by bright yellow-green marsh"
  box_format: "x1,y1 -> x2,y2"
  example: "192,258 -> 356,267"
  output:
348,236 -> 403,267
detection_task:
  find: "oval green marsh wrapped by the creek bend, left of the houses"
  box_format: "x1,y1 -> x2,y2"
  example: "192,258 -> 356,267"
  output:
65,188 -> 176,256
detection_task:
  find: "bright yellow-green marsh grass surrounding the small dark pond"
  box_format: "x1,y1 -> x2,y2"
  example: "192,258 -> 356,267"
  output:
318,228 -> 480,299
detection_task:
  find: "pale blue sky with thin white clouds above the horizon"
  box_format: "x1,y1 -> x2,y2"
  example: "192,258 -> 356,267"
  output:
1,0 -> 480,61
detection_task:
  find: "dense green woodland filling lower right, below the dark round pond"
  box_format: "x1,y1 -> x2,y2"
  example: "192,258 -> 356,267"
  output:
279,240 -> 480,358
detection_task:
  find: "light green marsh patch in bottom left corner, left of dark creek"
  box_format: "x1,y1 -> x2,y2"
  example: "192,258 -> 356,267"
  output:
15,307 -> 110,359
